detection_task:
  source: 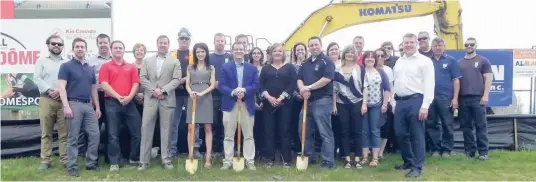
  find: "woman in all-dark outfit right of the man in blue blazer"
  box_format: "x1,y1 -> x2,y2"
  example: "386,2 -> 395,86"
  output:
259,43 -> 298,168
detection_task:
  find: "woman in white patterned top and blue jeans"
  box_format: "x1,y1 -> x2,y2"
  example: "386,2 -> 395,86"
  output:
360,51 -> 391,167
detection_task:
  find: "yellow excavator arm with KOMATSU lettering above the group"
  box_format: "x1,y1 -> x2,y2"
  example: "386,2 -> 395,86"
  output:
283,0 -> 463,50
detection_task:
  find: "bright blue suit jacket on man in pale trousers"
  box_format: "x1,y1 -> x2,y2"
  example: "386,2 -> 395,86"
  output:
218,61 -> 259,115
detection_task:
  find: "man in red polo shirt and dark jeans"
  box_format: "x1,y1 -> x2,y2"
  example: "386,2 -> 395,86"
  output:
99,41 -> 141,171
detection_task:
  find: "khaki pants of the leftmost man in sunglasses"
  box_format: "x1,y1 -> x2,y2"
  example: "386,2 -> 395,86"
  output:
39,96 -> 67,164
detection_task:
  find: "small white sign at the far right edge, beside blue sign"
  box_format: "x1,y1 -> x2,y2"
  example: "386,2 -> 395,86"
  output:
514,49 -> 536,77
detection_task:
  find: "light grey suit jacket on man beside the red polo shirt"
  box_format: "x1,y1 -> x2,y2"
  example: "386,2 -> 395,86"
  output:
140,54 -> 181,107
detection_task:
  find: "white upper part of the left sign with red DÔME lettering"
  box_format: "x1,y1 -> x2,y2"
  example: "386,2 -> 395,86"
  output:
0,18 -> 112,73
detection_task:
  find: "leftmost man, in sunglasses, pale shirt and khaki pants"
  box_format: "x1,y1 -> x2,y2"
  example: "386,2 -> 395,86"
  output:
33,35 -> 68,171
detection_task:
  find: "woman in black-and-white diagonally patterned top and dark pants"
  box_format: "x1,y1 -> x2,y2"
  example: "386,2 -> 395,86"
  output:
333,45 -> 365,169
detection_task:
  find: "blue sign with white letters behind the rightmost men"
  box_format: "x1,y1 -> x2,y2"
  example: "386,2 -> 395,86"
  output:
446,50 -> 514,107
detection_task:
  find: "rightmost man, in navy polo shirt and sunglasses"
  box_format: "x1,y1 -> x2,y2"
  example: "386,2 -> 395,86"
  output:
458,37 -> 493,160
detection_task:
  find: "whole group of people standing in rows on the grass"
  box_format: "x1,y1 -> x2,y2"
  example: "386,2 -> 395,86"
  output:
34,28 -> 492,177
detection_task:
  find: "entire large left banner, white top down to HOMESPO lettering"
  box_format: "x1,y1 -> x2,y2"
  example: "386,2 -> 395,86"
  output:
0,18 -> 112,120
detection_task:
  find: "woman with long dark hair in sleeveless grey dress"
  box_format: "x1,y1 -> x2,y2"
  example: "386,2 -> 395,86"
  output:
186,43 -> 216,168
